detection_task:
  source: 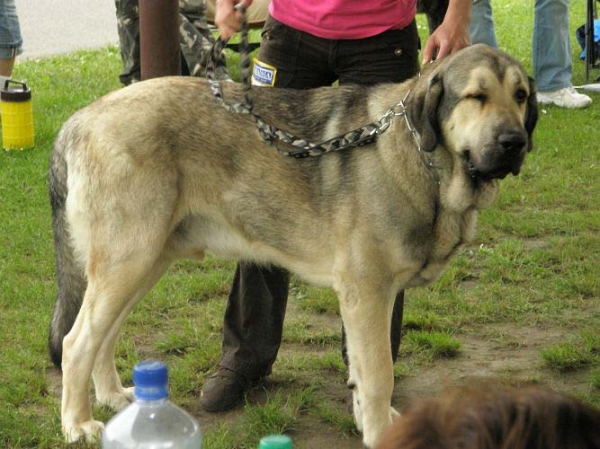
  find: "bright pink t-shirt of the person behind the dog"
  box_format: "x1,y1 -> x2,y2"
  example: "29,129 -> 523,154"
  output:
269,0 -> 417,39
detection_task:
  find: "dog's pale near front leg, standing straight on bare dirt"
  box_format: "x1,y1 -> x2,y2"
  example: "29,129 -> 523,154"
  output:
334,278 -> 398,447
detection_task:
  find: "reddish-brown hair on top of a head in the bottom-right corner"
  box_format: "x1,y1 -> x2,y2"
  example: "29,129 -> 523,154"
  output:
377,387 -> 600,449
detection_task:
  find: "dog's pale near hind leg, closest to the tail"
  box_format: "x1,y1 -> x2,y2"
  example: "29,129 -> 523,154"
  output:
61,248 -> 171,442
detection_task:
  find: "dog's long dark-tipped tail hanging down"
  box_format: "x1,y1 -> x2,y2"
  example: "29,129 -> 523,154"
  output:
48,126 -> 87,368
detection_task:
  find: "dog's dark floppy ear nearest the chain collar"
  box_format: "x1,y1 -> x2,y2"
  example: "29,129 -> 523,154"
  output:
409,72 -> 444,151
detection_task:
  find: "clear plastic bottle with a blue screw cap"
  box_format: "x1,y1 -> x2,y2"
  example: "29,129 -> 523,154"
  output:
102,361 -> 202,449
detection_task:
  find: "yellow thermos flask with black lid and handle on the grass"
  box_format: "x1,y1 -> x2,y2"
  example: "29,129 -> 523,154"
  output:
0,79 -> 35,150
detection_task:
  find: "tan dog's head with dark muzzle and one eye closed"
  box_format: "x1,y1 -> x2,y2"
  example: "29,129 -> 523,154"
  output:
408,45 -> 538,181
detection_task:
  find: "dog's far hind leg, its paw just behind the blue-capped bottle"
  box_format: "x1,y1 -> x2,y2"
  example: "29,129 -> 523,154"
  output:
92,257 -> 172,410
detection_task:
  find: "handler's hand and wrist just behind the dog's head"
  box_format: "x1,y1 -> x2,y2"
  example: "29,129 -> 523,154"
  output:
422,0 -> 471,64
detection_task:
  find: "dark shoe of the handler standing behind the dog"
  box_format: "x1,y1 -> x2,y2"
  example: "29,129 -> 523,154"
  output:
200,366 -> 261,412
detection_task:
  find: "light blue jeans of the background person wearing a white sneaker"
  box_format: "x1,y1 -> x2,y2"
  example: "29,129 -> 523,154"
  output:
469,0 -> 573,92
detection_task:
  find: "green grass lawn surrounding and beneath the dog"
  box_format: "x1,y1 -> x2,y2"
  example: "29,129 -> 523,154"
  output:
0,0 -> 600,449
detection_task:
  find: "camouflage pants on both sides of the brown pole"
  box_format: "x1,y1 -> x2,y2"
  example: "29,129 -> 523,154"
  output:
115,0 -> 229,85
